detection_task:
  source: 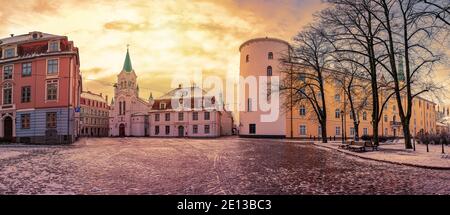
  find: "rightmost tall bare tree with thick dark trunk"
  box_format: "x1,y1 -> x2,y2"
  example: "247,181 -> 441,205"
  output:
372,0 -> 440,149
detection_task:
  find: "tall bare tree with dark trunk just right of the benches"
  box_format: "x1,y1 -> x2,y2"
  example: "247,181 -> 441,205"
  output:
321,0 -> 393,145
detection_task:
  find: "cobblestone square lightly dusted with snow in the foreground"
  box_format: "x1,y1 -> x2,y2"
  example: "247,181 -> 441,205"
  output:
0,137 -> 450,194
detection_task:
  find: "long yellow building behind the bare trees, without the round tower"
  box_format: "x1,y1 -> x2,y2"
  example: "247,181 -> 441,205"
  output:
285,71 -> 436,139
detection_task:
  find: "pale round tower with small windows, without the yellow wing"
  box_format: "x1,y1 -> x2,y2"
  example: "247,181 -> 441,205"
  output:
239,38 -> 289,138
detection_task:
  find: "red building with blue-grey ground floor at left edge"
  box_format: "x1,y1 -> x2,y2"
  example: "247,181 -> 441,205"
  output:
0,32 -> 82,144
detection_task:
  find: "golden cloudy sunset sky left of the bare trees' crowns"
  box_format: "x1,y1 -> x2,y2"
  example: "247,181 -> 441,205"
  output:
0,0 -> 323,101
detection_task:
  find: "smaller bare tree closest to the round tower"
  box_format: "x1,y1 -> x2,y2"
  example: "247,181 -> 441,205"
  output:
280,25 -> 332,143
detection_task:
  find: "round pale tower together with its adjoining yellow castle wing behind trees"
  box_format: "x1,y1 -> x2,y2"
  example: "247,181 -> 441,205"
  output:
239,38 -> 436,138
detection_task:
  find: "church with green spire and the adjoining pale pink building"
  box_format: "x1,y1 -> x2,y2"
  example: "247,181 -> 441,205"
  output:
109,50 -> 233,137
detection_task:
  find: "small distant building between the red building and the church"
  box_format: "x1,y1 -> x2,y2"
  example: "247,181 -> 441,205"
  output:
80,91 -> 109,137
